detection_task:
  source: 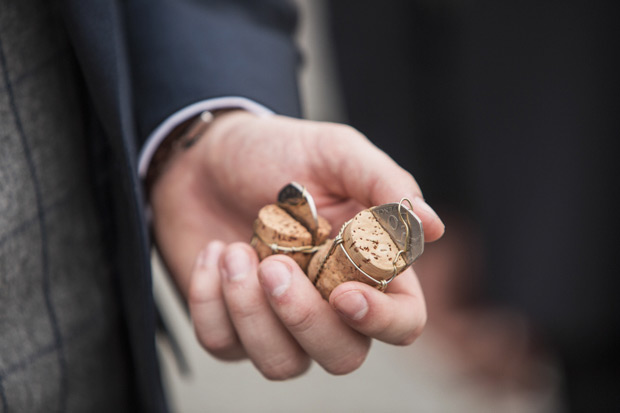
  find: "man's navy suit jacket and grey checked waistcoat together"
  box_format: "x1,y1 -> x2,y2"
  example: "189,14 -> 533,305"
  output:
0,0 -> 299,413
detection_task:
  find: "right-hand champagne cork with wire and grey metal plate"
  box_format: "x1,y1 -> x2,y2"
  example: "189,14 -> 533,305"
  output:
308,202 -> 424,299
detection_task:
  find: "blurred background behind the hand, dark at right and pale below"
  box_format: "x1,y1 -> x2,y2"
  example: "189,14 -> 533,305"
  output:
155,0 -> 620,412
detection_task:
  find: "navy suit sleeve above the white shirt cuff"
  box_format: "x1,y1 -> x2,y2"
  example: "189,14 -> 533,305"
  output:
125,0 -> 300,145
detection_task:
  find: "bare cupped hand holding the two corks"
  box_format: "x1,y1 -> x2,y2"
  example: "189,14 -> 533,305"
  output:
150,111 -> 444,380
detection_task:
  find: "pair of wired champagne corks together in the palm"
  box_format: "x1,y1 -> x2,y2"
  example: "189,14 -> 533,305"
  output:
252,183 -> 424,299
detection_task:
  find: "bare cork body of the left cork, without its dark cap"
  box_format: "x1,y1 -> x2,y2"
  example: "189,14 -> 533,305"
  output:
253,204 -> 331,272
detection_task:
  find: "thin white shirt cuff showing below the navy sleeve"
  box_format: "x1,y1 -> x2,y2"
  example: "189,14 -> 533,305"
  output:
138,96 -> 273,179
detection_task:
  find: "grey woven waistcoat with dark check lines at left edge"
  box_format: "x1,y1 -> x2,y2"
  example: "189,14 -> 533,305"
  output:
0,0 -> 130,412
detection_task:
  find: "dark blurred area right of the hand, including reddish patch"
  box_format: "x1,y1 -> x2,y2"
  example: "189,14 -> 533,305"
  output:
328,0 -> 620,412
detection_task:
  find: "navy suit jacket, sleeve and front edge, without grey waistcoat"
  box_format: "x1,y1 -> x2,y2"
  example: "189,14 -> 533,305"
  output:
59,0 -> 299,412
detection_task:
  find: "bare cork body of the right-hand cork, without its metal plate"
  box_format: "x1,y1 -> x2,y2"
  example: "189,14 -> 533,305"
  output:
308,209 -> 408,299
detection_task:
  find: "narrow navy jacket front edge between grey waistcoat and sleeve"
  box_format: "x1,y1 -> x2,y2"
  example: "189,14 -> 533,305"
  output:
63,0 -> 166,412
